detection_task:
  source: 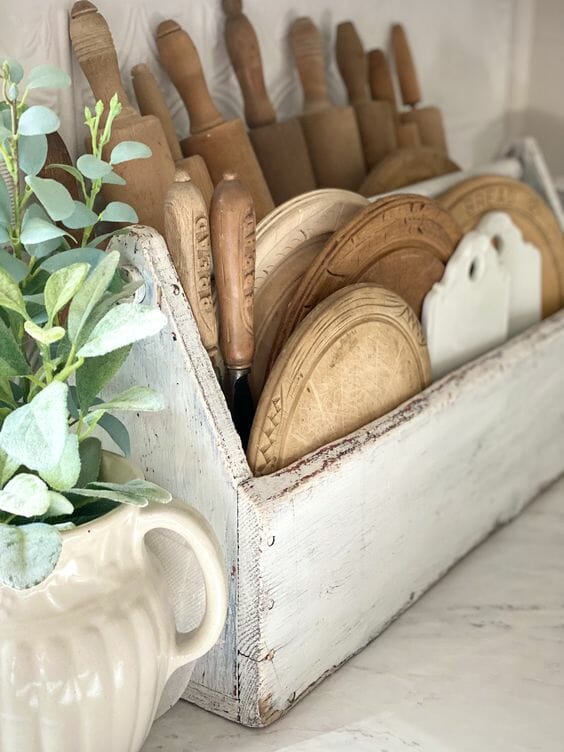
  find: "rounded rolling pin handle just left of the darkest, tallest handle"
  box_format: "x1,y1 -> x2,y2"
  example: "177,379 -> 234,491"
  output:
157,20 -> 223,135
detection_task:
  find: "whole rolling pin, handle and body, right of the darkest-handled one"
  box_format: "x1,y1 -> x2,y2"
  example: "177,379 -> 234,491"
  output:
290,17 -> 366,191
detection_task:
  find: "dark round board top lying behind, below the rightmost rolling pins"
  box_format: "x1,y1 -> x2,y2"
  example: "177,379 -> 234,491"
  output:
358,146 -> 460,196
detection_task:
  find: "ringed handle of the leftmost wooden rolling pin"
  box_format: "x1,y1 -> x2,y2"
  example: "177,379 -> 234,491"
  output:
69,0 -> 136,116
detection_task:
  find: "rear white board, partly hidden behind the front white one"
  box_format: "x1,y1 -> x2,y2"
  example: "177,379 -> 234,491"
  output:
476,212 -> 542,337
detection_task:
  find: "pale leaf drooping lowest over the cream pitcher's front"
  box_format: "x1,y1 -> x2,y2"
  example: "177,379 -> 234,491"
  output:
0,523 -> 63,590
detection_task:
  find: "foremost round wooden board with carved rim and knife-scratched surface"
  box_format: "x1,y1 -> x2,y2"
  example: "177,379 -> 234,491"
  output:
247,284 -> 431,475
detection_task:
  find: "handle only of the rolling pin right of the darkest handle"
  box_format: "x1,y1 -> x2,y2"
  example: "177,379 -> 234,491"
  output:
290,16 -> 331,113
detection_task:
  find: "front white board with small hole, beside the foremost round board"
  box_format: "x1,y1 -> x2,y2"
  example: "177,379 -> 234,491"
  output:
423,232 -> 510,379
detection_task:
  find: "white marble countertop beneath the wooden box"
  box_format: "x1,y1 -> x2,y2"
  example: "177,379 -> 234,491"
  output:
142,479 -> 564,752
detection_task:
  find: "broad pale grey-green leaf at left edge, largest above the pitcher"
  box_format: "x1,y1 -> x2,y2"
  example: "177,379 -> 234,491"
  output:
0,381 -> 68,472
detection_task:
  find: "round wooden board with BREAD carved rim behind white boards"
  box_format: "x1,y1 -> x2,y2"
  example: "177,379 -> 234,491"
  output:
438,175 -> 564,317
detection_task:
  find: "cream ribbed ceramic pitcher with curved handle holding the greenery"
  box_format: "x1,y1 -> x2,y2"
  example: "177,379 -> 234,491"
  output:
0,456 -> 227,752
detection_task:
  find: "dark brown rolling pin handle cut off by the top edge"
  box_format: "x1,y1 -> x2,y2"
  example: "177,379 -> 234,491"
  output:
223,0 -> 276,128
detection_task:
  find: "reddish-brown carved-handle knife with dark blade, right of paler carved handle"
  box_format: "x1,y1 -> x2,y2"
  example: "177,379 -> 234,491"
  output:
210,173 -> 256,447
